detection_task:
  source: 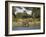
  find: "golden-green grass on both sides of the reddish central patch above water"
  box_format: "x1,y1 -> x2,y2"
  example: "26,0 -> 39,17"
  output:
12,18 -> 40,27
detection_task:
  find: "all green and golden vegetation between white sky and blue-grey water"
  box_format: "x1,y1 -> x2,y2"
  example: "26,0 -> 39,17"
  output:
12,7 -> 40,27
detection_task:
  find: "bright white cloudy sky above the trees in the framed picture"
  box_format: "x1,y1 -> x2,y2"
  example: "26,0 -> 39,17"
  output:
14,6 -> 32,15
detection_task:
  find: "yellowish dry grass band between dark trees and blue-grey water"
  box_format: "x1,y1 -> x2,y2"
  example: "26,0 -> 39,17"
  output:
12,18 -> 40,27
